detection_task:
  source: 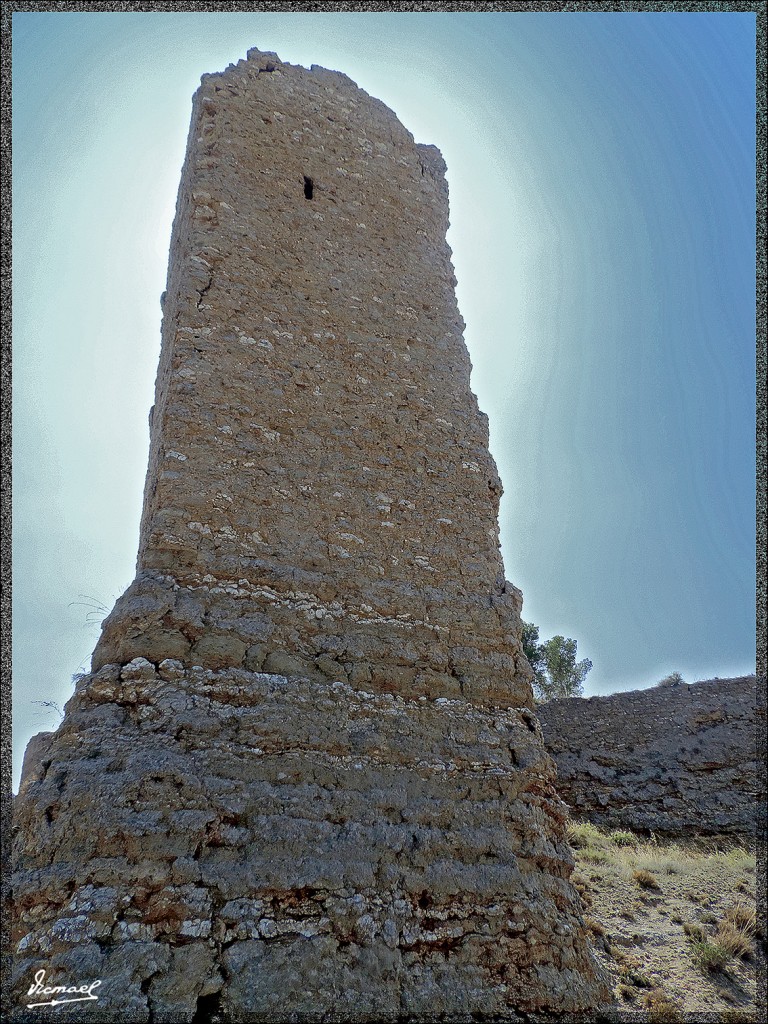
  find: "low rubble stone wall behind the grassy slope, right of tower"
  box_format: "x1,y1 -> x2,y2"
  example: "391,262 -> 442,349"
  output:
537,676 -> 765,835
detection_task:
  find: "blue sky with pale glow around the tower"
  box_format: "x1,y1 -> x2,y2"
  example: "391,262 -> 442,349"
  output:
12,11 -> 755,784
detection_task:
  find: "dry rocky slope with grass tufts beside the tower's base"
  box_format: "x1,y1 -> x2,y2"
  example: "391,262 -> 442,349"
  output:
569,822 -> 766,1024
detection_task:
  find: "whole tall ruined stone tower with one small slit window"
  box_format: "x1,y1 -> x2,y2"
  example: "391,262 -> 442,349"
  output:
14,50 -> 607,1024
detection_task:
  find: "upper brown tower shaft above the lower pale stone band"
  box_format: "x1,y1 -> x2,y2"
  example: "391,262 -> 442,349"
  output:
93,51 -> 529,706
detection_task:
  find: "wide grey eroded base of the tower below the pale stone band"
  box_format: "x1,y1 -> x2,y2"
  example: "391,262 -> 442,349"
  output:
14,659 -> 606,1024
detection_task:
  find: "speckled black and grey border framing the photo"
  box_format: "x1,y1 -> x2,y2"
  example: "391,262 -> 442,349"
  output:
0,8 -> 768,1022
